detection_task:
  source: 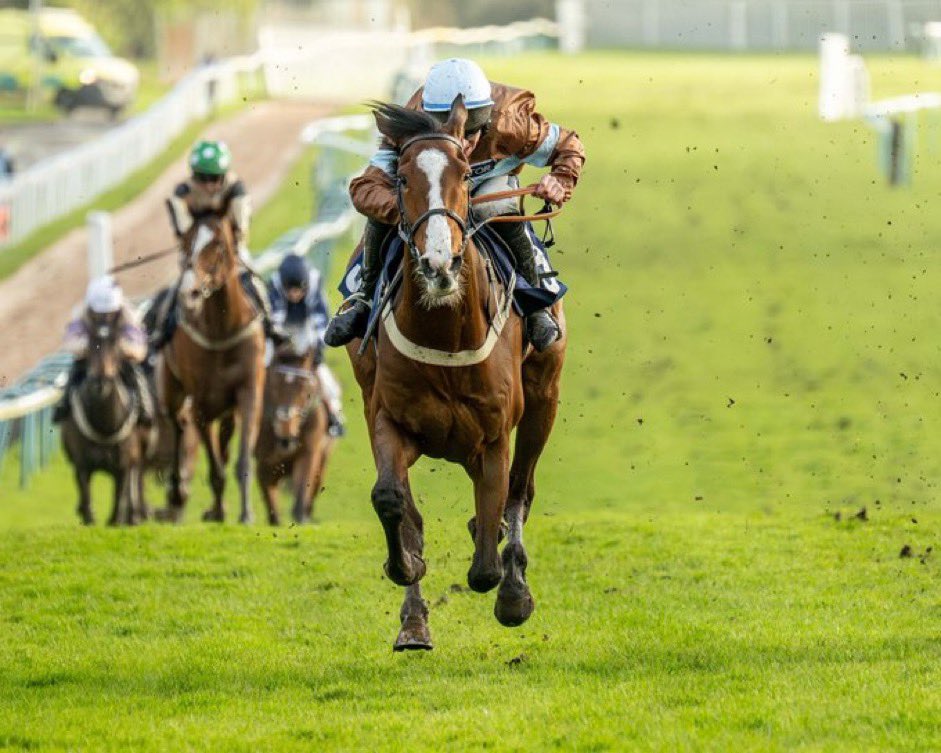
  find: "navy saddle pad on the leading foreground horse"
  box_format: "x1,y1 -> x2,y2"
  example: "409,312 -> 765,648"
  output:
338,222 -> 568,340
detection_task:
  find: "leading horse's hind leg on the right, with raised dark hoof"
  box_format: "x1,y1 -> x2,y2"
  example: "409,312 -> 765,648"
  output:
493,344 -> 563,627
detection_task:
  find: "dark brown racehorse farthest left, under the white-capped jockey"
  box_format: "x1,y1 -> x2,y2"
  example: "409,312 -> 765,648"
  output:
62,312 -> 152,526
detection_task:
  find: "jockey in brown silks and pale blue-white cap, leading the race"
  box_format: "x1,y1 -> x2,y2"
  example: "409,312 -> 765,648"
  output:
324,58 -> 585,351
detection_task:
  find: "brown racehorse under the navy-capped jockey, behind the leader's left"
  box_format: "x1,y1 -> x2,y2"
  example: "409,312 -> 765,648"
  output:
255,336 -> 333,525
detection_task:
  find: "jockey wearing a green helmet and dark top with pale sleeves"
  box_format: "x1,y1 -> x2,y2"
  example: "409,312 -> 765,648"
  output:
152,141 -> 280,350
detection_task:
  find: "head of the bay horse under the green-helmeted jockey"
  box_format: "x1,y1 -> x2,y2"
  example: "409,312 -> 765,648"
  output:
181,210 -> 238,308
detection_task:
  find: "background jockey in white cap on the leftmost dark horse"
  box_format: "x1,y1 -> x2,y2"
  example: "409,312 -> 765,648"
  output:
52,276 -> 154,427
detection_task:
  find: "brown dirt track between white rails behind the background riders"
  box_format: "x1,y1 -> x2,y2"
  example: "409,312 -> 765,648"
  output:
0,102 -> 323,386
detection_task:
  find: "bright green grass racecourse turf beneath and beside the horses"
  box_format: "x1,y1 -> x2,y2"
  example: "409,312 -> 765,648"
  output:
0,53 -> 941,751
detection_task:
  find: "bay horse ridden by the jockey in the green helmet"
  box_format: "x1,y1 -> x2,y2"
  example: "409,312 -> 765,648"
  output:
157,207 -> 265,523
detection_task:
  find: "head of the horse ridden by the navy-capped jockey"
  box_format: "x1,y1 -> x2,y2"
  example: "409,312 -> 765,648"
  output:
266,350 -> 320,451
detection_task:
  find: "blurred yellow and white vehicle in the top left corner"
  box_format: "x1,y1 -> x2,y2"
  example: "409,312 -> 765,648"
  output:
0,8 -> 140,115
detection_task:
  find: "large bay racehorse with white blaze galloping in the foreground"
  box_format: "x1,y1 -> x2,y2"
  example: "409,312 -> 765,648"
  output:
347,98 -> 566,651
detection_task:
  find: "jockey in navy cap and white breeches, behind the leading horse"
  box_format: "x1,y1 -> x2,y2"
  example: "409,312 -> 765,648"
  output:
268,254 -> 345,437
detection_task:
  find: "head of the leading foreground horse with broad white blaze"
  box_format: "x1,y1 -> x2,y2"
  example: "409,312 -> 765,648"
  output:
373,96 -> 470,308
